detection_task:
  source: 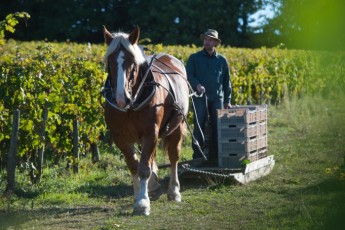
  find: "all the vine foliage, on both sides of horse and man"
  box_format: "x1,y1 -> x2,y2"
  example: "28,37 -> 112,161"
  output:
0,40 -> 345,179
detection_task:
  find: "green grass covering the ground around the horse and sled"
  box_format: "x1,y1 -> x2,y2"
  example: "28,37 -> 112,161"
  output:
0,95 -> 345,229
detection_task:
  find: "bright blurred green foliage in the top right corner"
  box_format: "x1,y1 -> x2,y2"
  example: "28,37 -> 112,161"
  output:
264,0 -> 345,49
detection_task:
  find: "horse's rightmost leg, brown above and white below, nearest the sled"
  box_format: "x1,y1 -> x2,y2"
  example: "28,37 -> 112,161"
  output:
164,123 -> 184,202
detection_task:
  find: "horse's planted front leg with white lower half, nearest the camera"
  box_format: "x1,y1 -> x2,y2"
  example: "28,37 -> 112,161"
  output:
133,135 -> 158,216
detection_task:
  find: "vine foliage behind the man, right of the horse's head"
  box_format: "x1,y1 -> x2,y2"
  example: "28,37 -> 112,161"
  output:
148,44 -> 345,105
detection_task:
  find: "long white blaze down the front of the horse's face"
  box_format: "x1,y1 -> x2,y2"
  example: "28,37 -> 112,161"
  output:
116,51 -> 126,108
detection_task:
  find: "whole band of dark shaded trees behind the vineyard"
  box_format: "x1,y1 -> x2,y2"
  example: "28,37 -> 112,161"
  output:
0,0 -> 269,46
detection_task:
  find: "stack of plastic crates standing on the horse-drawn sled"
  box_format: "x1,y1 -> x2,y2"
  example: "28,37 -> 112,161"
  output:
217,105 -> 267,168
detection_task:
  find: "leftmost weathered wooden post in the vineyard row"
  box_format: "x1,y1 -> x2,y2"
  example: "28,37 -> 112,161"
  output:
6,109 -> 20,192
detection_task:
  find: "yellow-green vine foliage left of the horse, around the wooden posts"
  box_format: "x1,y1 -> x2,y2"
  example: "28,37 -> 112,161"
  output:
0,43 -> 105,164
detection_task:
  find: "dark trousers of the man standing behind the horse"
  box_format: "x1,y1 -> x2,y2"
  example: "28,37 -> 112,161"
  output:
192,96 -> 223,161
